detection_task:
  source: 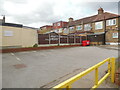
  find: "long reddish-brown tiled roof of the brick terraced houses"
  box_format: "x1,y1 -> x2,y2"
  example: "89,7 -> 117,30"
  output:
68,12 -> 120,26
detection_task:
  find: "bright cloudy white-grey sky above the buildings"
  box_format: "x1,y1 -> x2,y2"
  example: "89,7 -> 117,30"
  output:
0,0 -> 119,28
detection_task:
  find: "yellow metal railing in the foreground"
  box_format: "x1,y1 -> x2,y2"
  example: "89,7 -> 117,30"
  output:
52,58 -> 115,90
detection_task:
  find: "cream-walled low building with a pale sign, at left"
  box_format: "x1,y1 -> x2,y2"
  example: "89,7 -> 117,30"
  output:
0,17 -> 38,49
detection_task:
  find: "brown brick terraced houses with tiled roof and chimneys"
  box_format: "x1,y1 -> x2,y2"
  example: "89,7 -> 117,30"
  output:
63,8 -> 120,44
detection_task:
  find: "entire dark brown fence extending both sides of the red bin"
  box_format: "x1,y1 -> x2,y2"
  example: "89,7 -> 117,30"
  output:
38,32 -> 105,45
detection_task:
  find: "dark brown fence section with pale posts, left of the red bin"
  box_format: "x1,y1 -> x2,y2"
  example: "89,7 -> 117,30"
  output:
38,33 -> 86,44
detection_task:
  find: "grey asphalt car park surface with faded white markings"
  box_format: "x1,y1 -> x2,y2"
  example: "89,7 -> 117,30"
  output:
2,46 -> 118,88
